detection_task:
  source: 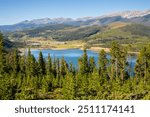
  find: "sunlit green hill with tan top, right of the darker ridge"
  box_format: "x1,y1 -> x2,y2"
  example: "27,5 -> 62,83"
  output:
87,23 -> 150,51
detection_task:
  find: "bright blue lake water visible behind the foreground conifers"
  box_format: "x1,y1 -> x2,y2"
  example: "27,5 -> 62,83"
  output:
31,49 -> 136,69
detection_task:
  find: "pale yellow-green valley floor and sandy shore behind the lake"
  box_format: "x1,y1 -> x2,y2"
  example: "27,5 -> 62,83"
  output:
19,39 -> 139,54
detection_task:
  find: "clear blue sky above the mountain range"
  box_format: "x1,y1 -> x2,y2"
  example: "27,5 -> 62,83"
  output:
0,0 -> 150,25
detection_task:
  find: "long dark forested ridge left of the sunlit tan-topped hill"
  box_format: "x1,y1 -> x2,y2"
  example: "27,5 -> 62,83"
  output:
5,25 -> 101,41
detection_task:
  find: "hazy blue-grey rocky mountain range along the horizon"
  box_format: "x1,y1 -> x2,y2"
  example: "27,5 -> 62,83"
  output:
0,10 -> 150,32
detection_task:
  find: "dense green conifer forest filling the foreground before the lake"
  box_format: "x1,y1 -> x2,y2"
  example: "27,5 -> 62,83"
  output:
0,34 -> 150,100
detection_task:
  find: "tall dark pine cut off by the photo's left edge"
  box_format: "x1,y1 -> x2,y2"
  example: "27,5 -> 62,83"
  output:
0,33 -> 16,100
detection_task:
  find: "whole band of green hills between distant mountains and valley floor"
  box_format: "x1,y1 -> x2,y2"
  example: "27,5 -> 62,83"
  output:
4,22 -> 150,51
